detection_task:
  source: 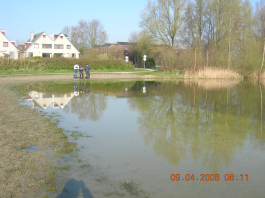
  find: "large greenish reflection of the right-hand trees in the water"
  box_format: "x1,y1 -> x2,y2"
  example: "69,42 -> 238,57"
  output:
128,82 -> 265,173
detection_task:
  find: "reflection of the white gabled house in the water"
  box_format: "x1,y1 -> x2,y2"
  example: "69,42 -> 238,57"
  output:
28,91 -> 74,110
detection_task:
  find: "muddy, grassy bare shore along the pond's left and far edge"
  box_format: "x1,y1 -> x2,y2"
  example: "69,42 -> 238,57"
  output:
0,73 -> 155,198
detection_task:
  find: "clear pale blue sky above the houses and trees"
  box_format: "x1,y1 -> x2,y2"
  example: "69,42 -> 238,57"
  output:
0,0 -> 257,43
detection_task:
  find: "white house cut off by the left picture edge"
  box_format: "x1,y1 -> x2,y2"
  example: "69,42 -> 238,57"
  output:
0,29 -> 19,59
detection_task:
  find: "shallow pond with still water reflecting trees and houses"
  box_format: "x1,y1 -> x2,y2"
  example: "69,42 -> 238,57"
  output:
20,80 -> 265,198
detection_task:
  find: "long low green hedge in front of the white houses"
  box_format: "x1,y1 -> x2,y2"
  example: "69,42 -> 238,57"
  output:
0,57 -> 134,70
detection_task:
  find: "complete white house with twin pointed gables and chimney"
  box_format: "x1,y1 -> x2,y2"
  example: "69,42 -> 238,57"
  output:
19,32 -> 80,58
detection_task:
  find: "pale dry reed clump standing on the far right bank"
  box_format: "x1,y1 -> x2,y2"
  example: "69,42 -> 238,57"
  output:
184,67 -> 241,78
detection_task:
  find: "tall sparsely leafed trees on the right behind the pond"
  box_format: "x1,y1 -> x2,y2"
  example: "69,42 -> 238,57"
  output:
129,0 -> 265,75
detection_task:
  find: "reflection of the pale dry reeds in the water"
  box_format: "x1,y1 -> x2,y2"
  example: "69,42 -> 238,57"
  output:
184,79 -> 240,90
